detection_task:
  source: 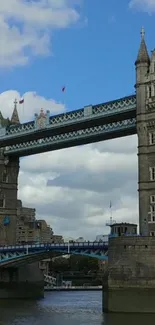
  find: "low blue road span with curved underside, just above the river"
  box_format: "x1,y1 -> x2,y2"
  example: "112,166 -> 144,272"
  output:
0,242 -> 108,267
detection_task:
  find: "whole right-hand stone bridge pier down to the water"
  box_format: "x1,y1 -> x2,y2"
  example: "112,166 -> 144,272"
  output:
103,237 -> 155,313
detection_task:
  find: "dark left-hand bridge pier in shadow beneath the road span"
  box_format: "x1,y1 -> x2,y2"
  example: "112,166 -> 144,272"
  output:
0,263 -> 44,299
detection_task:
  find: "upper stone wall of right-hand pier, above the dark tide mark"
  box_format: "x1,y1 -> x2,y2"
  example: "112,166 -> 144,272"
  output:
108,237 -> 155,288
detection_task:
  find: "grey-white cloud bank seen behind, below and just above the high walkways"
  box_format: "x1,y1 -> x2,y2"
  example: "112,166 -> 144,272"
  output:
0,91 -> 138,239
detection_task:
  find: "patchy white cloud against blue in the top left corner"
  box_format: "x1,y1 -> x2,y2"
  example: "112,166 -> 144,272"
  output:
0,0 -> 81,67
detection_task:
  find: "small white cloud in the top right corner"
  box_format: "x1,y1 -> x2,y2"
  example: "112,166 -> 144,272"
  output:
129,0 -> 155,14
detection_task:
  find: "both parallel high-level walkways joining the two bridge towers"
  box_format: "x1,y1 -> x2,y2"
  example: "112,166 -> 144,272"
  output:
0,95 -> 136,157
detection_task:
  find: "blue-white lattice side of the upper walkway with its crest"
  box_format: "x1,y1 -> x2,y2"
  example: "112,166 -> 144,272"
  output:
0,95 -> 136,139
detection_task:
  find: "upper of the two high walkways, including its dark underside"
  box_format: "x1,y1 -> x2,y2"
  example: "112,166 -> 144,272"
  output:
0,95 -> 136,147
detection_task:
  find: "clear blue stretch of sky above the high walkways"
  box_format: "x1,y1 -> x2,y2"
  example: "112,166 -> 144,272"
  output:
0,0 -> 155,114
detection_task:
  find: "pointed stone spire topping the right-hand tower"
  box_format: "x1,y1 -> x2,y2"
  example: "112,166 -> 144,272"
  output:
135,27 -> 150,65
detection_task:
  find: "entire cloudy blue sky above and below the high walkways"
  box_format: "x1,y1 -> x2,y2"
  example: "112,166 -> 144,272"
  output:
0,0 -> 155,239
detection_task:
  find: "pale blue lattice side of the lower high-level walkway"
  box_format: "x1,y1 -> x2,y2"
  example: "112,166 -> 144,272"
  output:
4,118 -> 136,156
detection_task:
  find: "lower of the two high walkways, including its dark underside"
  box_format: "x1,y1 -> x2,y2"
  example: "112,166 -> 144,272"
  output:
4,118 -> 136,156
